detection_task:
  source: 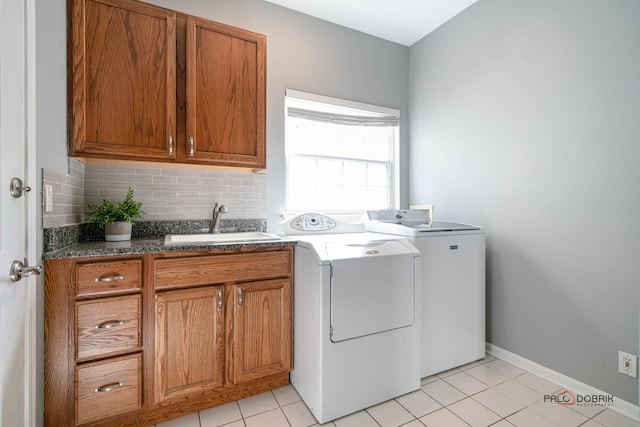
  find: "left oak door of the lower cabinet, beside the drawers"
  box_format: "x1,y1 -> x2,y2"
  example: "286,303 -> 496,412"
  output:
155,286 -> 224,403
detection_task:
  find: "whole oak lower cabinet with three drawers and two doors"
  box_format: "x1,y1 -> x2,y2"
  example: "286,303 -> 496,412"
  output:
44,246 -> 293,427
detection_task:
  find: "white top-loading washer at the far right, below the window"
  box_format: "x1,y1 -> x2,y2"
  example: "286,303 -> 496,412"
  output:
366,209 -> 486,377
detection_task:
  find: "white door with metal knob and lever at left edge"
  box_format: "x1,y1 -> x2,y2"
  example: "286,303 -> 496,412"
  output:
0,0 -> 37,426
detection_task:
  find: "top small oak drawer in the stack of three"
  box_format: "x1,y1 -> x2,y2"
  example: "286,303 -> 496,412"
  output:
76,259 -> 142,296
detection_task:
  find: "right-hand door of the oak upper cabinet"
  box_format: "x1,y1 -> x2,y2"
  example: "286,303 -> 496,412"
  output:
185,16 -> 266,169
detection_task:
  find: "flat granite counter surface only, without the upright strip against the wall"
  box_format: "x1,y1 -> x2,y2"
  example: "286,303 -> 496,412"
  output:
42,237 -> 296,260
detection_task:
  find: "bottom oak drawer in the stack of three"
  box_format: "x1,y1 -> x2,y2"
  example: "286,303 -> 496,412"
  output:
76,354 -> 142,424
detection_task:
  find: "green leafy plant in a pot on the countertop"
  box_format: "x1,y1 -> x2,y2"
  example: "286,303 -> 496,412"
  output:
88,187 -> 146,242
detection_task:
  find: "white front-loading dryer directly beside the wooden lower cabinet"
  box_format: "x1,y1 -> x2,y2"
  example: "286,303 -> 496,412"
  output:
283,213 -> 420,423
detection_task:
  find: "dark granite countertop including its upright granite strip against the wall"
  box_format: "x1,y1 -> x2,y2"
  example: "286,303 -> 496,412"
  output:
42,219 -> 296,260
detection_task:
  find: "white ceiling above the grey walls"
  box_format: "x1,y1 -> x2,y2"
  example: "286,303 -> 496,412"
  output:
265,0 -> 477,46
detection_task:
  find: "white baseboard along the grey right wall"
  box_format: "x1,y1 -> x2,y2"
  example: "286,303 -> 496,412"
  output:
486,343 -> 640,421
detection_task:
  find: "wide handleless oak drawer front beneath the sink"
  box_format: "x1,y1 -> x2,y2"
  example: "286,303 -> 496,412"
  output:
155,251 -> 292,289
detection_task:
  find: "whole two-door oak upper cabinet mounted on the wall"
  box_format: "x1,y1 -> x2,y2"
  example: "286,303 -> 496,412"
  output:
68,0 -> 266,169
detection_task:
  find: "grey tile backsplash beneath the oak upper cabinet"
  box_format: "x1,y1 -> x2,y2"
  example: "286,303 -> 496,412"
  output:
42,158 -> 266,228
